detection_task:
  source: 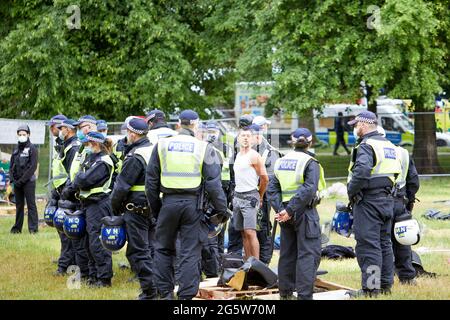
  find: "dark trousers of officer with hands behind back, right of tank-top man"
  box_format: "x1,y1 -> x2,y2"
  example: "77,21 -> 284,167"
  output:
278,209 -> 321,300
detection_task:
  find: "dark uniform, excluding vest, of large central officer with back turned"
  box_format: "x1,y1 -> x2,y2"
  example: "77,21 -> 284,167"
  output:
145,129 -> 226,299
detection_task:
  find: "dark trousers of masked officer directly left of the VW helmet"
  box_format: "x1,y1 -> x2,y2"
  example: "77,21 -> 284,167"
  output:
83,198 -> 113,280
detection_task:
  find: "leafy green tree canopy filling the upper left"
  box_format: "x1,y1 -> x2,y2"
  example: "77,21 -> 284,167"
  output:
0,0 -> 216,120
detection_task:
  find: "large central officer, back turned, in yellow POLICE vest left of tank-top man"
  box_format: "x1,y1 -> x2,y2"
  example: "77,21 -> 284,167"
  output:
145,110 -> 226,299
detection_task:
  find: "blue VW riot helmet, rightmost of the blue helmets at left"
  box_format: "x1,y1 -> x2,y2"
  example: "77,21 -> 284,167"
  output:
100,216 -> 127,252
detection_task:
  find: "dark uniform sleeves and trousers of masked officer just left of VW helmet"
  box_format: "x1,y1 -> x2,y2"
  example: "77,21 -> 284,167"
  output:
71,152 -> 114,284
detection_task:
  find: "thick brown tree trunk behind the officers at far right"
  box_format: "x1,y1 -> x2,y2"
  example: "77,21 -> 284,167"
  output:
413,103 -> 443,174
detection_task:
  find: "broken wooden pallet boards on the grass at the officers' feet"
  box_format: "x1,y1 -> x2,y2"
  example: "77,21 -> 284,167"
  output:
196,278 -> 354,300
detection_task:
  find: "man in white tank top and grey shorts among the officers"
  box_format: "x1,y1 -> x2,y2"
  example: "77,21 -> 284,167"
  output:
233,128 -> 269,259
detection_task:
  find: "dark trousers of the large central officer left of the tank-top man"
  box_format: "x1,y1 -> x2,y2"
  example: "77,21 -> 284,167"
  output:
155,195 -> 208,299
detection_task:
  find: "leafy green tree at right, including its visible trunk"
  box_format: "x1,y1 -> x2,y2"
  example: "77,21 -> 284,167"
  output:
206,0 -> 449,172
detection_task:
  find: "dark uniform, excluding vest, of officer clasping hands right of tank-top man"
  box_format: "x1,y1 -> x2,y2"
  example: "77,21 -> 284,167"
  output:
266,149 -> 321,300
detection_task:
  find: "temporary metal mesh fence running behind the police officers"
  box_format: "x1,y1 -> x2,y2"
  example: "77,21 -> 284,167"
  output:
0,110 -> 450,193
